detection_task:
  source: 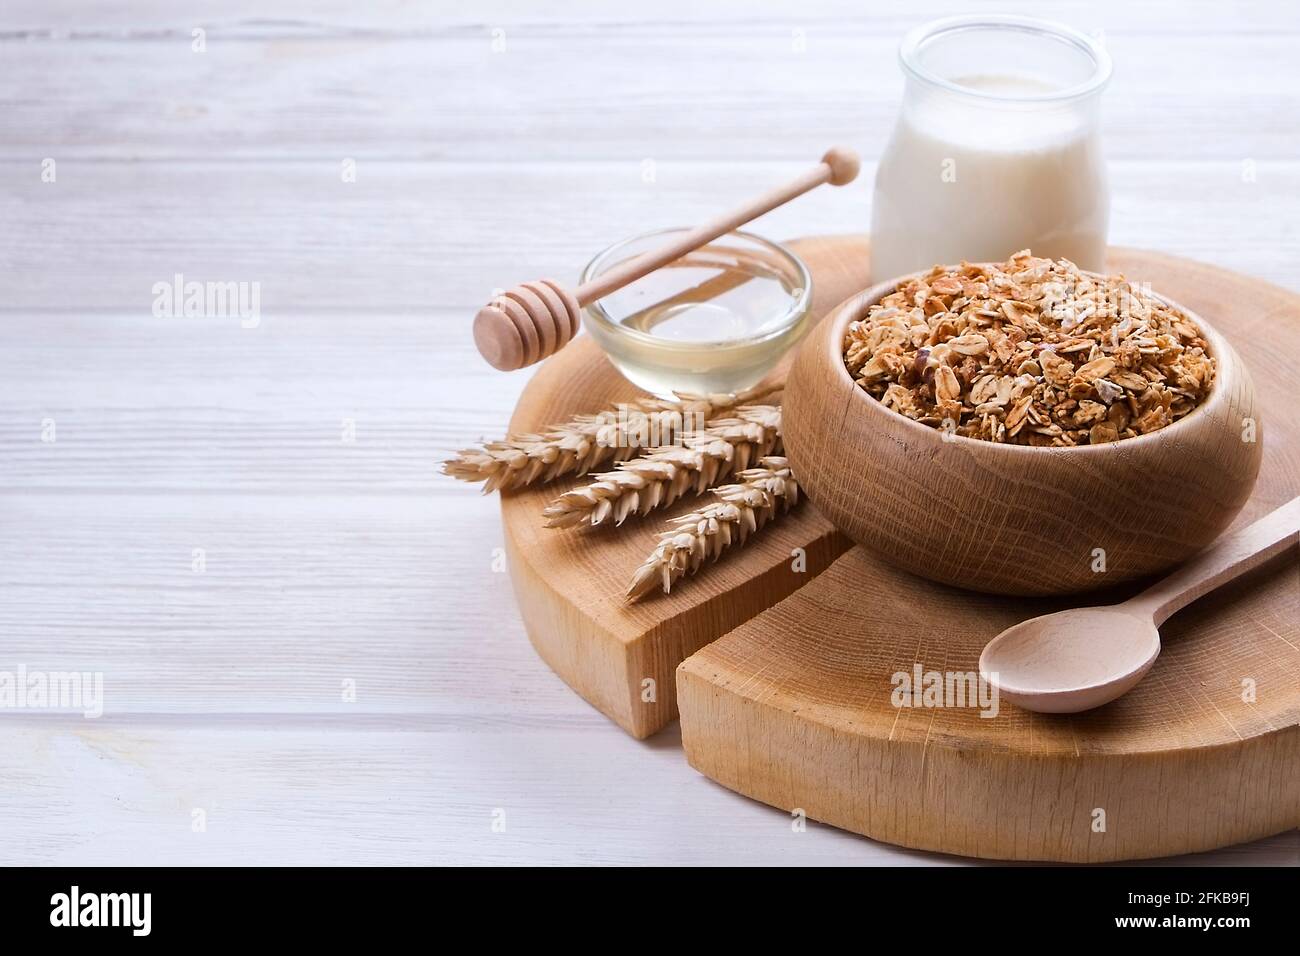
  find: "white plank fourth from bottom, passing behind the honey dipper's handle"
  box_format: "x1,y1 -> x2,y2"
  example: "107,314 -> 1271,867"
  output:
0,160 -> 1300,310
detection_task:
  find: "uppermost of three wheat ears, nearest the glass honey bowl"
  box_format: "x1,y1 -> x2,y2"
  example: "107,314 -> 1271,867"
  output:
442,385 -> 780,494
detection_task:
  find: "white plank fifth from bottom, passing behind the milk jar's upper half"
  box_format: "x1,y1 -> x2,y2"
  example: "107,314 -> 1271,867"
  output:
0,28 -> 1300,163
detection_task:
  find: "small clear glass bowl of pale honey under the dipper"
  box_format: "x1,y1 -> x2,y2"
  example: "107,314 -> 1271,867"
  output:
581,229 -> 813,398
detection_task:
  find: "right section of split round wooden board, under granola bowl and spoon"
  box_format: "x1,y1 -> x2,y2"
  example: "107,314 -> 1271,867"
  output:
677,250 -> 1300,862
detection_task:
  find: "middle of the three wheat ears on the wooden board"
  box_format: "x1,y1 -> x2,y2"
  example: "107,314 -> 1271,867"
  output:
542,405 -> 781,528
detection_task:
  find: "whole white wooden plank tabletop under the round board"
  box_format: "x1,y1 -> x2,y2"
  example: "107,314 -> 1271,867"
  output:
0,0 -> 1300,864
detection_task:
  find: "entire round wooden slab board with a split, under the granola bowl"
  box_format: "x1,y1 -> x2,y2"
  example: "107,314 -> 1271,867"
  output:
502,237 -> 1300,861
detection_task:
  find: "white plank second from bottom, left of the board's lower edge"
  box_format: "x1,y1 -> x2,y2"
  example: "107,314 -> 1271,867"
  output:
0,489 -> 603,717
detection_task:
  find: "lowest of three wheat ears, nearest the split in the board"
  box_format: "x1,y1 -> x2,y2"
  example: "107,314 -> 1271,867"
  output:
627,457 -> 800,601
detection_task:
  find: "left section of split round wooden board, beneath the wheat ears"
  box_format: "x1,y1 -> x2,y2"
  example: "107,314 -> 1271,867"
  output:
502,237 -> 867,737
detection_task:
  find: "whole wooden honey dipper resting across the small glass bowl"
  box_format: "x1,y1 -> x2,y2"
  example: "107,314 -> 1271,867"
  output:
475,146 -> 862,372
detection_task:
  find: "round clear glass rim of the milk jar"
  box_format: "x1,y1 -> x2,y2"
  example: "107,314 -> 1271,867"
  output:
898,14 -> 1112,105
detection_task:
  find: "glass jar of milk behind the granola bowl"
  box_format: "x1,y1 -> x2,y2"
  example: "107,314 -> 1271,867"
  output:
871,17 -> 1110,282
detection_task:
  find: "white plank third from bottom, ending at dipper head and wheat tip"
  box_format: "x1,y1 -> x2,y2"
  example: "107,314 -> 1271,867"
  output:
0,310 -> 522,497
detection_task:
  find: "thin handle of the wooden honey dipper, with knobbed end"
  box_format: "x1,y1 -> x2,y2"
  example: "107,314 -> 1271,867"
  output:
573,146 -> 861,306
